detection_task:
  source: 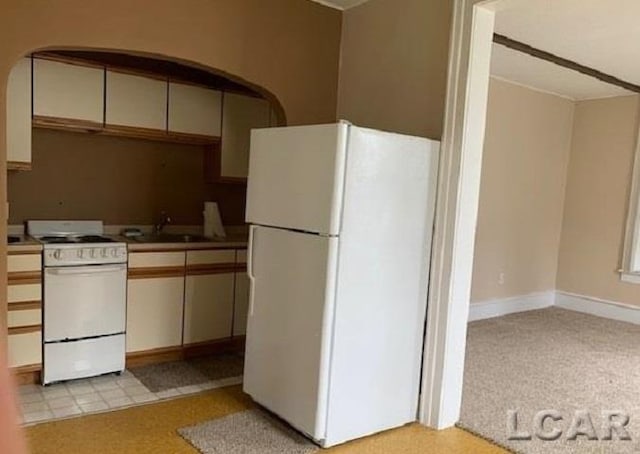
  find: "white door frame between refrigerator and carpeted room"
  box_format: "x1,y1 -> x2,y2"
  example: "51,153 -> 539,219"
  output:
419,0 -> 495,429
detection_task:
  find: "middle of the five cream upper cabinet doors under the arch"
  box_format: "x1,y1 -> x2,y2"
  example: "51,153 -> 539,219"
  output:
105,71 -> 167,131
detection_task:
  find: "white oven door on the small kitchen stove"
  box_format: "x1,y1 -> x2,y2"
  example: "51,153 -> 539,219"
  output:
43,263 -> 127,342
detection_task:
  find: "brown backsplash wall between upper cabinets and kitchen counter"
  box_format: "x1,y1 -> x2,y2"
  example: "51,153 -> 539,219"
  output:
8,129 -> 246,225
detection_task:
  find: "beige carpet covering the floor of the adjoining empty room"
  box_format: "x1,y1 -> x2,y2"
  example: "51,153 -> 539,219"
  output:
459,308 -> 640,454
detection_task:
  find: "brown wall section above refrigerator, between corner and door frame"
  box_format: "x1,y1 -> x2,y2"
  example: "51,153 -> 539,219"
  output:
338,0 -> 453,139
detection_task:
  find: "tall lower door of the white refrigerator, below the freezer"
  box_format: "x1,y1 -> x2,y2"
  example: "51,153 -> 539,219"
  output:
244,226 -> 338,440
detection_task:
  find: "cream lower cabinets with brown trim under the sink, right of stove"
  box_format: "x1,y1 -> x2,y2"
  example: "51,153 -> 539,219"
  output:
125,249 -> 249,353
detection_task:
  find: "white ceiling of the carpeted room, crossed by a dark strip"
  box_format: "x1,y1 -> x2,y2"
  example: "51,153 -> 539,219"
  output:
492,0 -> 640,99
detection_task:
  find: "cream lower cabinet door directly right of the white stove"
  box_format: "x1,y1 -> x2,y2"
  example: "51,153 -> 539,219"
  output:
127,277 -> 184,352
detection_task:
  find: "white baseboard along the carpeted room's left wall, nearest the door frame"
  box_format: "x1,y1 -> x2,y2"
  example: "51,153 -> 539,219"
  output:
469,290 -> 555,322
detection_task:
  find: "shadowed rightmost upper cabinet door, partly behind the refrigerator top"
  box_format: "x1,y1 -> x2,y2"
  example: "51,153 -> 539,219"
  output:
220,93 -> 271,178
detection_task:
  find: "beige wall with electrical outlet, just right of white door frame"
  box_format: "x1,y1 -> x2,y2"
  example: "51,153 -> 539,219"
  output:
472,79 -> 574,302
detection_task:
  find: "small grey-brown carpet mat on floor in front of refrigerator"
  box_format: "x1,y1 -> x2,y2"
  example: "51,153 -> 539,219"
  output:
178,409 -> 320,454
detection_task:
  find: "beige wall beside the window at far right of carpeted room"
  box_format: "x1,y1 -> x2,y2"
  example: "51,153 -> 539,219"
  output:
558,96 -> 640,305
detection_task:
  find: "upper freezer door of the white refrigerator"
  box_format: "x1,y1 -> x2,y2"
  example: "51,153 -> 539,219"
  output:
246,123 -> 349,235
